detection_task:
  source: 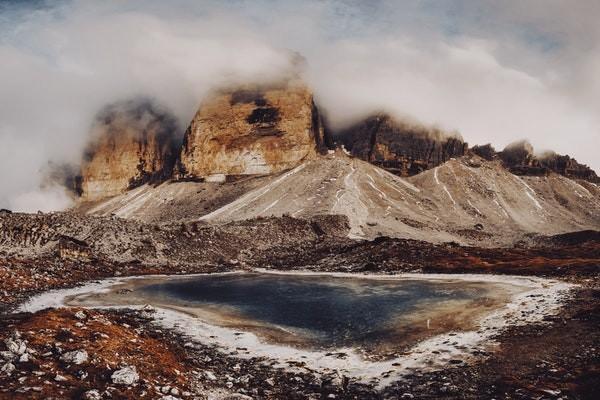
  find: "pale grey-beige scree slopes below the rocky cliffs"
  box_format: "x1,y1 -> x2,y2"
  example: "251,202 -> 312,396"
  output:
80,150 -> 600,246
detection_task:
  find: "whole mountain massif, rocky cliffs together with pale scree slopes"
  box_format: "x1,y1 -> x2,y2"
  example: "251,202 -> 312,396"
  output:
75,78 -> 600,247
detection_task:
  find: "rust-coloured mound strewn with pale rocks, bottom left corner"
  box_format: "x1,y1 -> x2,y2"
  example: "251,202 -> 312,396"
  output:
0,309 -> 192,399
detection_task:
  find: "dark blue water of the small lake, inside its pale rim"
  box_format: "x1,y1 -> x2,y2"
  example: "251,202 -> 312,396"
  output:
139,274 -> 487,347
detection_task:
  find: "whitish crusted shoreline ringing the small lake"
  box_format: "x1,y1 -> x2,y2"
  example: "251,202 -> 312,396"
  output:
21,270 -> 574,387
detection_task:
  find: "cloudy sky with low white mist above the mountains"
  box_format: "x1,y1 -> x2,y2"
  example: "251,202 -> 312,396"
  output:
0,0 -> 600,211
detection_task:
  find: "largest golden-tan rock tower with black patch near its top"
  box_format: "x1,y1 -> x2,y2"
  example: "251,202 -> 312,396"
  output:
175,81 -> 326,179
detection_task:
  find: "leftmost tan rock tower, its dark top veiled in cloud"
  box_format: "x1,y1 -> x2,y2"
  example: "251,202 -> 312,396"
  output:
79,101 -> 176,200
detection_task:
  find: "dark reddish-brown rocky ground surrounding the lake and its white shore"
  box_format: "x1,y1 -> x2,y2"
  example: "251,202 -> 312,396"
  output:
0,214 -> 600,400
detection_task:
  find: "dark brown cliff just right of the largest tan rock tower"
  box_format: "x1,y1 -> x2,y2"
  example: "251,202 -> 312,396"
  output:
336,114 -> 468,176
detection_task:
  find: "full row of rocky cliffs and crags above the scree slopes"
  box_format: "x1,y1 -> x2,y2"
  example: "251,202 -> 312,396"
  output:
77,88 -> 600,200
